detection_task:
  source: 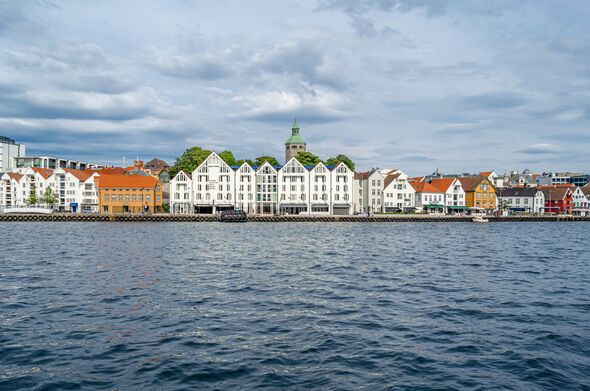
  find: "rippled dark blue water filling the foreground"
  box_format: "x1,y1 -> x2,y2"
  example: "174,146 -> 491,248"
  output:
0,223 -> 590,390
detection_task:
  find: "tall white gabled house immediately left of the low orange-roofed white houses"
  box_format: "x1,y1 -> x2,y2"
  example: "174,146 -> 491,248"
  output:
383,171 -> 416,213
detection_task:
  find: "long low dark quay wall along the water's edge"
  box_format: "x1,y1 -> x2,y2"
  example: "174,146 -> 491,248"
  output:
0,213 -> 590,223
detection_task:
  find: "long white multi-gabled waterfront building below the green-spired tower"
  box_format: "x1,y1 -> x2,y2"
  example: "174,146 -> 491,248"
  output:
170,153 -> 354,215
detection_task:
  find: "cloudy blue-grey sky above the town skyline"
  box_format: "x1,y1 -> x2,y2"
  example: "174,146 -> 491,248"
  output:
0,0 -> 590,175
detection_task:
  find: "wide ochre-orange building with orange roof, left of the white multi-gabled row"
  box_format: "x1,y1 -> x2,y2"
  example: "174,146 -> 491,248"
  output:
94,175 -> 163,213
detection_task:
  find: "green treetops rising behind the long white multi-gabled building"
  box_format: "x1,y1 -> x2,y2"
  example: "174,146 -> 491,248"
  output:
170,147 -> 355,177
